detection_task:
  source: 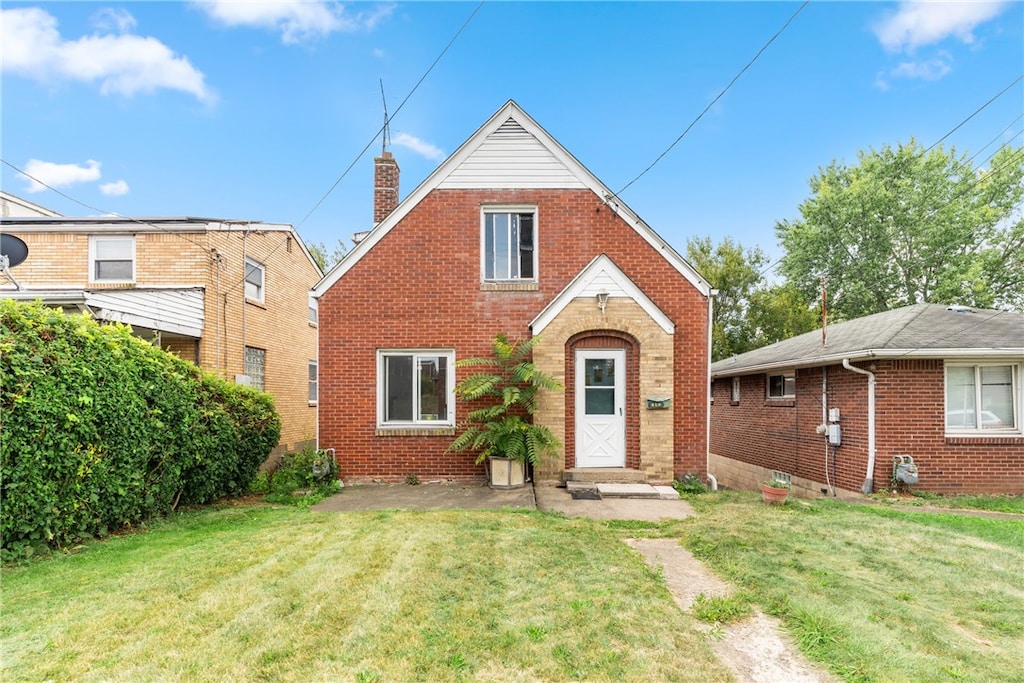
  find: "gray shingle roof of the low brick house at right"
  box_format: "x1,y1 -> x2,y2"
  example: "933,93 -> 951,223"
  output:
711,303 -> 1024,377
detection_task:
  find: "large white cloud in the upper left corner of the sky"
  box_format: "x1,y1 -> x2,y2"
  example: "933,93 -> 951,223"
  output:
0,7 -> 214,101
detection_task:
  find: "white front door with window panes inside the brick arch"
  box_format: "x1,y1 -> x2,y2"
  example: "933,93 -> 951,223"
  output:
575,348 -> 626,467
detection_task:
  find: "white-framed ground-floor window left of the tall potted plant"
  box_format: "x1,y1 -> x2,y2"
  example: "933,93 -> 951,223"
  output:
377,350 -> 455,427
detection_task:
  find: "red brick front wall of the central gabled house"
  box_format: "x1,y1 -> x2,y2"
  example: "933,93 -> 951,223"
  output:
319,189 -> 708,480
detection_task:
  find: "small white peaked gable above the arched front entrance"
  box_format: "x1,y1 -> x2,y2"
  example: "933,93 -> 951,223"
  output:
529,254 -> 676,335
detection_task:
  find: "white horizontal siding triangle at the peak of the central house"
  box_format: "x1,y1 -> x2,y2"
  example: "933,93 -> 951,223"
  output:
438,119 -> 587,189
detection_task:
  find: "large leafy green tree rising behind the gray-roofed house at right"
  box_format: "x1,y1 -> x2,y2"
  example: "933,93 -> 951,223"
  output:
775,139 -> 1024,319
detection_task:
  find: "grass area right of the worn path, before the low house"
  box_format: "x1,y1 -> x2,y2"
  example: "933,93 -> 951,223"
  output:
683,492 -> 1024,682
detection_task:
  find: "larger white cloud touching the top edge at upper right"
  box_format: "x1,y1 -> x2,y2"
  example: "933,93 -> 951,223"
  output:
872,2 -> 1009,52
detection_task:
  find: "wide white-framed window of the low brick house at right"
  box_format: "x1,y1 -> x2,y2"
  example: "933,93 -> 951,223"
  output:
945,364 -> 1021,434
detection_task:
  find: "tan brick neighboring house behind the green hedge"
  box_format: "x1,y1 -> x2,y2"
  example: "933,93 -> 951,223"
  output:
0,208 -> 323,452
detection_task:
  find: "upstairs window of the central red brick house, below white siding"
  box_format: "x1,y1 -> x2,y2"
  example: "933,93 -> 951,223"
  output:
480,207 -> 537,282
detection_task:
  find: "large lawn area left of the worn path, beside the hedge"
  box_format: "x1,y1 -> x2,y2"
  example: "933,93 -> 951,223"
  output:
0,506 -> 728,681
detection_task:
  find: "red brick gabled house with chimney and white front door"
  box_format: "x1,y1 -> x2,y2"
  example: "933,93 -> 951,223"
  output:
315,101 -> 712,482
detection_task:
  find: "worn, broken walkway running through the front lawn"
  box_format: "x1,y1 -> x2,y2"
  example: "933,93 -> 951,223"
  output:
626,539 -> 839,683
